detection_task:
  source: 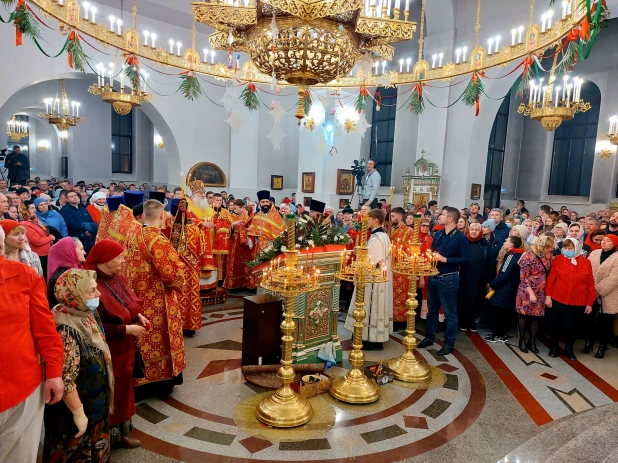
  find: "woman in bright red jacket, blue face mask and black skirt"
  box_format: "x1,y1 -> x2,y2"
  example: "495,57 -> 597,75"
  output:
545,238 -> 597,360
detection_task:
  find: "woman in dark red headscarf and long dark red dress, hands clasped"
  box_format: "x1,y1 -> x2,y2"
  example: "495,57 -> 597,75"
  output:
84,240 -> 150,448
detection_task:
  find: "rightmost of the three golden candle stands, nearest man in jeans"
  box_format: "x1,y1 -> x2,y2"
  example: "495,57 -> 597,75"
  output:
388,215 -> 438,383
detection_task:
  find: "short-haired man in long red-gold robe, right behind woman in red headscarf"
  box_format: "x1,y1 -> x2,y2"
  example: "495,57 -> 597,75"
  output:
126,200 -> 186,391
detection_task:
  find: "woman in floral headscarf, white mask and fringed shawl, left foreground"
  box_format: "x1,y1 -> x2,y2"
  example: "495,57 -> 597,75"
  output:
43,269 -> 114,463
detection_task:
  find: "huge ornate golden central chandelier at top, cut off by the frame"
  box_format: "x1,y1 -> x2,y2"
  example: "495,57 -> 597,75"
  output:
192,0 -> 416,108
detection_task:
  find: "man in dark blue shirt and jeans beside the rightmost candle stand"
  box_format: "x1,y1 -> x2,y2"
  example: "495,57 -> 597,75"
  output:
418,207 -> 470,355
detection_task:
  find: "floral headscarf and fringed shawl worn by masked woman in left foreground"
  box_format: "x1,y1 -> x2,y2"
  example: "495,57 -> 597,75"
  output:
52,269 -> 114,414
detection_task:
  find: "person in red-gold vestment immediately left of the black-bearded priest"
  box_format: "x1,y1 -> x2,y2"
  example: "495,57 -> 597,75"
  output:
223,199 -> 253,289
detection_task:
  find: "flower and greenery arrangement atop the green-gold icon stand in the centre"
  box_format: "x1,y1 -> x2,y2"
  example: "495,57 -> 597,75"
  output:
246,217 -> 350,268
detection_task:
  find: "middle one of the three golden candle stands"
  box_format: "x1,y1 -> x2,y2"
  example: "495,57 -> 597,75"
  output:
329,215 -> 388,404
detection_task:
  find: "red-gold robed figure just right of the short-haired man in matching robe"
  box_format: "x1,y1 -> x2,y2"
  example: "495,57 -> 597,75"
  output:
163,198 -> 206,336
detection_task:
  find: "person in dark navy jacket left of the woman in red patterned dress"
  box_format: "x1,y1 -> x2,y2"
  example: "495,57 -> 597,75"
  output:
485,236 -> 524,346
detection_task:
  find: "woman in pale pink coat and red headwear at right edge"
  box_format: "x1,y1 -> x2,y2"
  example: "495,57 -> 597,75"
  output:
586,234 -> 618,359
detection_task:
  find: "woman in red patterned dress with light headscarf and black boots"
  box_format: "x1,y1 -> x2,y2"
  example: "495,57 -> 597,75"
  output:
515,236 -> 554,353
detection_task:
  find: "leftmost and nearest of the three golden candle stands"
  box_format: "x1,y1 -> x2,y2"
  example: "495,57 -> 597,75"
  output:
255,215 -> 320,428
